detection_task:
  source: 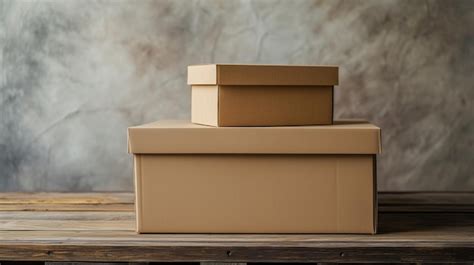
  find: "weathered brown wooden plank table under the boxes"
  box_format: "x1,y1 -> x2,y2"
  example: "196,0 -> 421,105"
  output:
0,193 -> 474,263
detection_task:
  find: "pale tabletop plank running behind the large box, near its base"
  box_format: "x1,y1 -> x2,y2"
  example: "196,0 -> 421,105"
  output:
0,208 -> 474,234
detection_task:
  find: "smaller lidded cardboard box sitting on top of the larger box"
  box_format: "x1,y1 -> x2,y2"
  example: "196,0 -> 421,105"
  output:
188,64 -> 338,126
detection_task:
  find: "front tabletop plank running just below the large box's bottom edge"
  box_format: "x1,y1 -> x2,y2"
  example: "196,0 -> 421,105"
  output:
0,227 -> 474,245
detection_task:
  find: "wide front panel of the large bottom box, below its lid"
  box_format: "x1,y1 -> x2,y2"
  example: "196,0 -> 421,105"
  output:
135,155 -> 374,233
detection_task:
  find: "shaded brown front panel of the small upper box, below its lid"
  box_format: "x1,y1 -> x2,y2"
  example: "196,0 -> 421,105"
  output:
219,86 -> 333,126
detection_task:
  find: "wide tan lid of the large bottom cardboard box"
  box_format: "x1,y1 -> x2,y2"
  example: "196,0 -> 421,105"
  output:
128,120 -> 381,154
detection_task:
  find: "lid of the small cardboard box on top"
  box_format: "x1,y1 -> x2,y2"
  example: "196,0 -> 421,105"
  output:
188,64 -> 339,86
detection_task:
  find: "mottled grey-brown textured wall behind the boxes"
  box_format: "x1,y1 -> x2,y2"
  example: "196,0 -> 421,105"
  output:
0,0 -> 474,191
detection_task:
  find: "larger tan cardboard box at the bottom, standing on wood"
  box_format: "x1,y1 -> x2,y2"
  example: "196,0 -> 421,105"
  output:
128,121 -> 380,233
